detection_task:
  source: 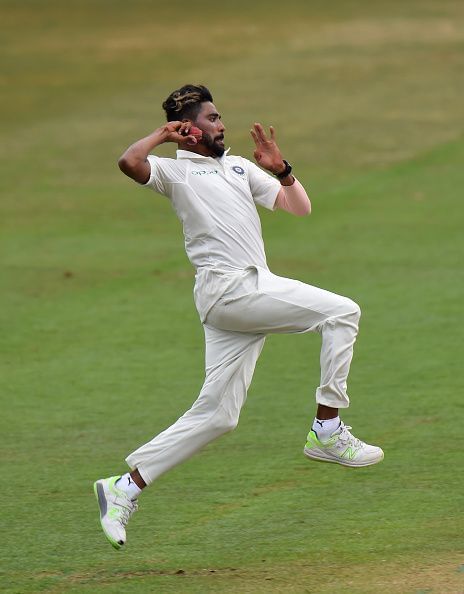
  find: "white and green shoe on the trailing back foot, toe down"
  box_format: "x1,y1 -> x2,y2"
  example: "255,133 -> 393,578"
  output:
93,476 -> 137,549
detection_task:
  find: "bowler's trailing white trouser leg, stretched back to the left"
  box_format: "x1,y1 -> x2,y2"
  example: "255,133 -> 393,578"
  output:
126,325 -> 265,485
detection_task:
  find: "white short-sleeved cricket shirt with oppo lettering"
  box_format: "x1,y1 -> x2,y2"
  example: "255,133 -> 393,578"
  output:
146,150 -> 281,321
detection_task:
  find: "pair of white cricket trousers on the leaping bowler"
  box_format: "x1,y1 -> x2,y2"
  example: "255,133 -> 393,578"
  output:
126,267 -> 361,485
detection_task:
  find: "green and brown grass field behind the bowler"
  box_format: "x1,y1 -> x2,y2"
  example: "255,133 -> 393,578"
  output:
0,0 -> 464,594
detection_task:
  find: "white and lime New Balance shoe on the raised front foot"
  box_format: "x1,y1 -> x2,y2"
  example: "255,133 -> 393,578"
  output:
304,422 -> 383,467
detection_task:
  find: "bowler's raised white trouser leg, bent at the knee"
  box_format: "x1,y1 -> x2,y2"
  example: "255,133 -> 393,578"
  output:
208,269 -> 361,409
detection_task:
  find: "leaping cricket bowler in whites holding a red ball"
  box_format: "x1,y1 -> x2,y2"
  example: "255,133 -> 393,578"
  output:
94,85 -> 383,549
